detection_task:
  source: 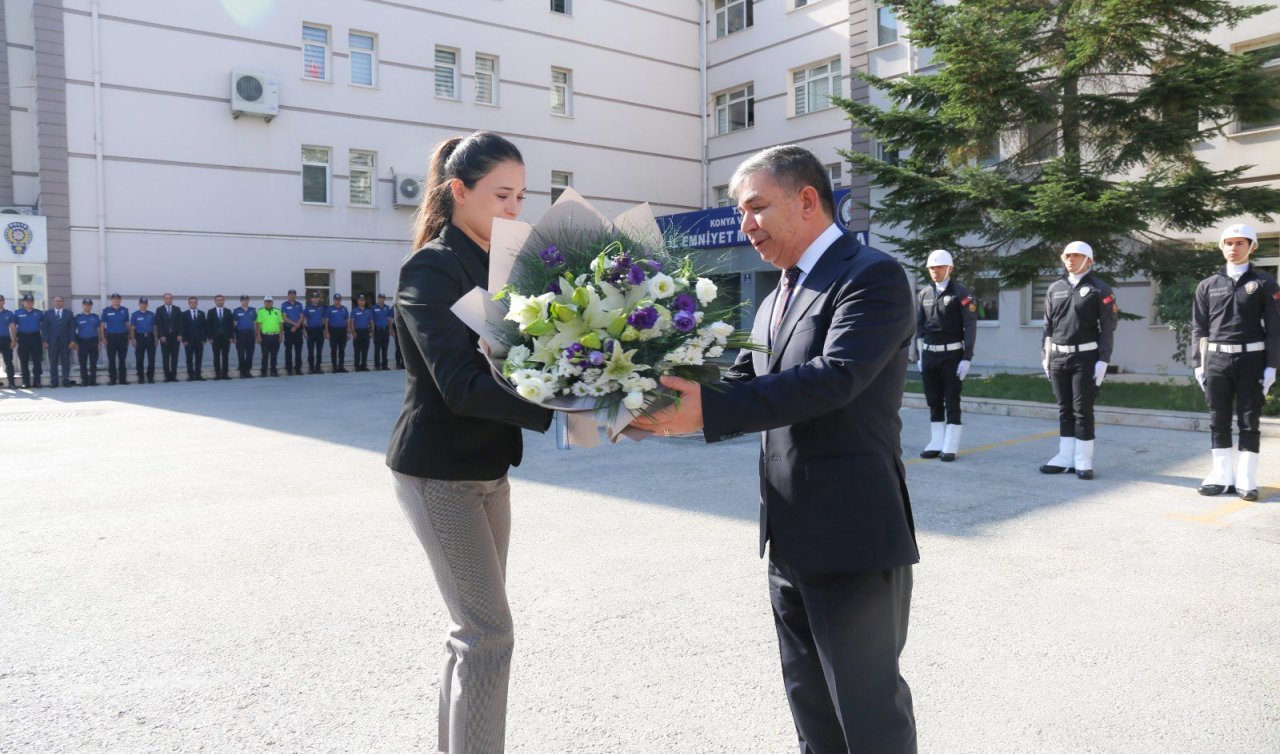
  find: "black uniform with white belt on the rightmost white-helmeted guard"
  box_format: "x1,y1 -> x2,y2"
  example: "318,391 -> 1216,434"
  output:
1192,265 -> 1280,453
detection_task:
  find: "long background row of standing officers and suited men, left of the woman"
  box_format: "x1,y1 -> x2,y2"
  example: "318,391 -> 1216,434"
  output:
0,289 -> 403,388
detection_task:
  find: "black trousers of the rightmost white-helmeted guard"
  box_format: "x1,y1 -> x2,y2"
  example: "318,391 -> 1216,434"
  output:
1204,351 -> 1267,453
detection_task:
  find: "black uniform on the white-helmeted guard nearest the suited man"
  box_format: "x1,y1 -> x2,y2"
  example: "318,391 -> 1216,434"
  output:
915,280 -> 978,424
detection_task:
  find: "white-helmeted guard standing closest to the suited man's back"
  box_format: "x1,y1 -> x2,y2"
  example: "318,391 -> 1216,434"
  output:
915,248 -> 978,461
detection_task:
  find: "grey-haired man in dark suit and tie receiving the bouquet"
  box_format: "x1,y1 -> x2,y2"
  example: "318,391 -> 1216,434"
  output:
636,146 -> 919,754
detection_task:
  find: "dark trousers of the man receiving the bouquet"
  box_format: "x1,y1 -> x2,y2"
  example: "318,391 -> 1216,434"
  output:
769,548 -> 916,754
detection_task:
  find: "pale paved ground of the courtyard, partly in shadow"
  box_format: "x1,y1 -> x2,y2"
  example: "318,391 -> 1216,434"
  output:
0,373 -> 1280,754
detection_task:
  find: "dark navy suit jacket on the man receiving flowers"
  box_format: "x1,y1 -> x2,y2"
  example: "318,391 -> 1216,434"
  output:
701,234 -> 920,574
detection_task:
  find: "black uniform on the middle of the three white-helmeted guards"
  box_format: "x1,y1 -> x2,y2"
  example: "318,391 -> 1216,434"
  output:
1042,271 -> 1120,440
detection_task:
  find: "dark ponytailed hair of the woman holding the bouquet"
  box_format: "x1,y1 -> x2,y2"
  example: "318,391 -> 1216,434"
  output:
413,131 -> 525,248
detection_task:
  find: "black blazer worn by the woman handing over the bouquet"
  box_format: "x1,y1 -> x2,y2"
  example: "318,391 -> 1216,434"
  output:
387,224 -> 552,480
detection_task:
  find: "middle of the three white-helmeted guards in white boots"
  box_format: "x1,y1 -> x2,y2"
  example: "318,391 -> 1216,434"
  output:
1041,241 -> 1120,479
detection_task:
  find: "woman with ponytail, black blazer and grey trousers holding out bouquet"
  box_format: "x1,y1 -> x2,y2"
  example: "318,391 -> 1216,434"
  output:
387,132 -> 552,754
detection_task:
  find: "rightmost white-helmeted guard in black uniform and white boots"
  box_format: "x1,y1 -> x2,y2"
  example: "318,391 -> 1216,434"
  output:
1192,225 -> 1280,501
